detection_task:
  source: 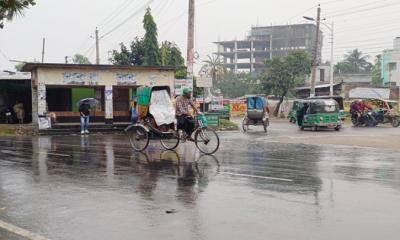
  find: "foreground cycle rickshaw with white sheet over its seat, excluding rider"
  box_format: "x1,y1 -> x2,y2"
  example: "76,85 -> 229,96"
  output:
125,86 -> 220,154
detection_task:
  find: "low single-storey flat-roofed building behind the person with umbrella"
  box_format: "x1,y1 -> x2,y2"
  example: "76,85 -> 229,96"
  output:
23,63 -> 175,128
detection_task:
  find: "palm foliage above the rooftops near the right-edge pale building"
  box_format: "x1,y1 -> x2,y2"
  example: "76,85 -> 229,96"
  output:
335,49 -> 372,73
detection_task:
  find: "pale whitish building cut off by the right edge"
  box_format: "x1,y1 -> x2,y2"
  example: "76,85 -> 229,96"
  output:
382,37 -> 400,86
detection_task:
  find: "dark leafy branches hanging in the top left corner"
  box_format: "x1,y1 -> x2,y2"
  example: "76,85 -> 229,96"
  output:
0,0 -> 36,28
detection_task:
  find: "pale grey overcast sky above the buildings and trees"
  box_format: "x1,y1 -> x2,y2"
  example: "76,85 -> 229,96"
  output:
0,0 -> 400,70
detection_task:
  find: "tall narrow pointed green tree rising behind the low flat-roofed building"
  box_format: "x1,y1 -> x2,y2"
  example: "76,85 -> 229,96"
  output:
143,8 -> 161,66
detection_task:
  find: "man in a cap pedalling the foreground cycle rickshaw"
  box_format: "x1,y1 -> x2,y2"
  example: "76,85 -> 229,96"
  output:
175,88 -> 198,141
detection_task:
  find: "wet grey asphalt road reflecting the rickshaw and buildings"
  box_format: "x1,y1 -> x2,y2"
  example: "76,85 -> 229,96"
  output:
0,124 -> 400,240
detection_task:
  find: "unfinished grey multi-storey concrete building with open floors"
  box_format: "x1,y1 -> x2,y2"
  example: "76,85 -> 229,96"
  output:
215,24 -> 323,73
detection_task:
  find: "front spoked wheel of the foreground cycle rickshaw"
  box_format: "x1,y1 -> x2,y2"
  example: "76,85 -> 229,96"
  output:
194,128 -> 219,154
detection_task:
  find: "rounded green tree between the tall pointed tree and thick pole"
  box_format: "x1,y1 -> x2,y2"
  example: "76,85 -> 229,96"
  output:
160,41 -> 185,66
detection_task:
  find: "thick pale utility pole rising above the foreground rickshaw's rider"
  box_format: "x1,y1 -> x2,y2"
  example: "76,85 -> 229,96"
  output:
187,0 -> 195,79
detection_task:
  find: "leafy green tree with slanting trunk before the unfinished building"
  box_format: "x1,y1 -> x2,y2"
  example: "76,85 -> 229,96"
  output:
261,51 -> 312,116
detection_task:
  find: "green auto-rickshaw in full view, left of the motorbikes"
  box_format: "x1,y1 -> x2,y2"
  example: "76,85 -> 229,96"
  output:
297,99 -> 342,131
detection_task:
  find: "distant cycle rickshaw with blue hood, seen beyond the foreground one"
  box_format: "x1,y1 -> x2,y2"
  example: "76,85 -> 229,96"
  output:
242,95 -> 269,132
